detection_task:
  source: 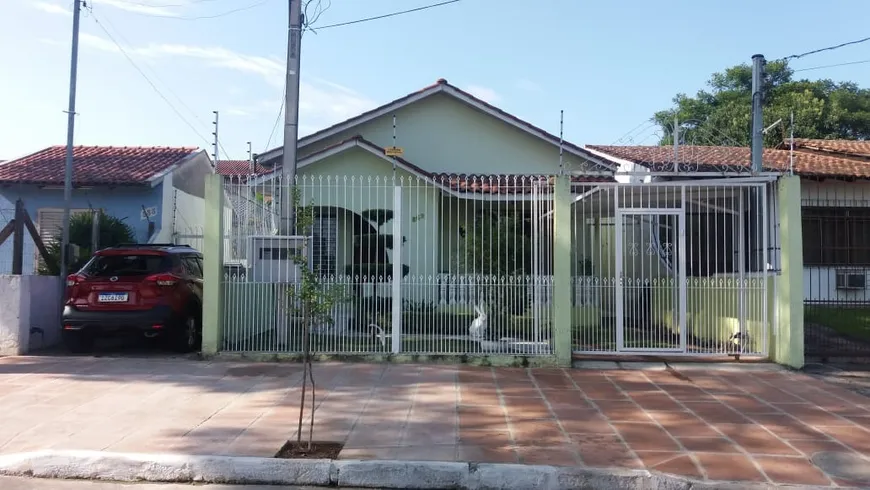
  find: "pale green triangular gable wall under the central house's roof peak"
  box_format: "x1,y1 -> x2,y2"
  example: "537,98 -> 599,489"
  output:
300,94 -> 583,175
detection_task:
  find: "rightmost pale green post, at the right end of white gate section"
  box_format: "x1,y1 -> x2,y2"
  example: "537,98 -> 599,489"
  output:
765,175 -> 804,369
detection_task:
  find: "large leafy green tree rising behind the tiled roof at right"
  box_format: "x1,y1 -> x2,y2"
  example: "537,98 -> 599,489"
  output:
653,61 -> 870,147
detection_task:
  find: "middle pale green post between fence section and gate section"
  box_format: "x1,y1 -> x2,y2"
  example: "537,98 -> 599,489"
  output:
551,175 -> 573,367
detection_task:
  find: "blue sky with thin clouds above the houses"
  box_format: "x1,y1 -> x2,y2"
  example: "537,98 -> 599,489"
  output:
0,0 -> 870,160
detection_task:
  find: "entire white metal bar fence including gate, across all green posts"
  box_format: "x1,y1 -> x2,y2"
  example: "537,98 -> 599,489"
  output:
211,175 -> 779,356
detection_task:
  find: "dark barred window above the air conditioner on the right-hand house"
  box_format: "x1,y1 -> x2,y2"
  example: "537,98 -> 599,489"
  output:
801,207 -> 870,266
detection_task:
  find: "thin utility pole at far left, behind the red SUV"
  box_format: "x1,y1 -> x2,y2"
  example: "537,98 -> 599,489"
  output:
60,0 -> 82,285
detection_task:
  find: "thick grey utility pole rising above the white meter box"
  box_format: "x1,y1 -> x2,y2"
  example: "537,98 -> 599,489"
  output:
279,0 -> 303,235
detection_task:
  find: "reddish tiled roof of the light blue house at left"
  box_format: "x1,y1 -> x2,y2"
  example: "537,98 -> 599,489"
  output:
0,146 -> 197,186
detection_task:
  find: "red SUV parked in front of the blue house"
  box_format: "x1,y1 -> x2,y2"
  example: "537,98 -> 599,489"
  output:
63,244 -> 202,353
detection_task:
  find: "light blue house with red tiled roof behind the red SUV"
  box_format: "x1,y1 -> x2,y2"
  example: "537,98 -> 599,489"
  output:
0,146 -> 214,272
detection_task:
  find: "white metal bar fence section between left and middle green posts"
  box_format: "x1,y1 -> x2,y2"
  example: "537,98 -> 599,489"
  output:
223,175 -> 552,355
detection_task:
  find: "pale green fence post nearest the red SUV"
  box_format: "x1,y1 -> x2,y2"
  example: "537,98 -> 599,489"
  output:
202,175 -> 224,355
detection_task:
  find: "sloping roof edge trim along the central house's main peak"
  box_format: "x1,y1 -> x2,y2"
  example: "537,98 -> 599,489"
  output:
260,78 -> 615,171
